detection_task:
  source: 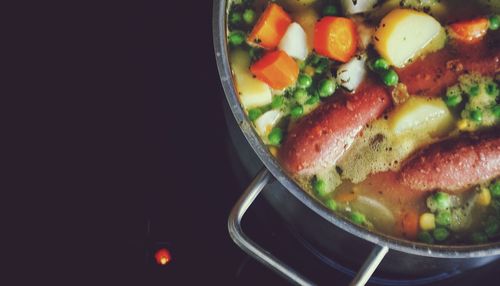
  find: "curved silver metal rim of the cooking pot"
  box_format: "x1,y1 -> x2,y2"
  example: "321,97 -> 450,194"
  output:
212,0 -> 500,258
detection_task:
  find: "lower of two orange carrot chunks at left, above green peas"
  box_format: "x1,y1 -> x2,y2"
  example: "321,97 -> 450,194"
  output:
250,51 -> 299,89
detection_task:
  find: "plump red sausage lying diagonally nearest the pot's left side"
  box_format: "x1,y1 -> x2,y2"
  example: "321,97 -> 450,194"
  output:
278,80 -> 391,175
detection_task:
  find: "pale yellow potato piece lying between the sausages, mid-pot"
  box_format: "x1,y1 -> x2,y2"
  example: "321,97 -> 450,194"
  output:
388,97 -> 454,136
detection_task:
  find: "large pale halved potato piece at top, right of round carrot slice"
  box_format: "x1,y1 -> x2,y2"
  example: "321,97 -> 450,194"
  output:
374,9 -> 441,67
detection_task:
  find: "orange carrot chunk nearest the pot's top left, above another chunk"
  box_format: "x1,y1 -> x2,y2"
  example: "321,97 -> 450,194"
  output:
247,3 -> 292,49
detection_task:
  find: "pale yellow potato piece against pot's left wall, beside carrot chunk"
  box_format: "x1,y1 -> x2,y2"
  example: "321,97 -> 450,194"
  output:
230,49 -> 273,109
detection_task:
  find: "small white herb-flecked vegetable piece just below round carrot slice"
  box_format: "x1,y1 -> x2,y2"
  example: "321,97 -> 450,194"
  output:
337,54 -> 367,91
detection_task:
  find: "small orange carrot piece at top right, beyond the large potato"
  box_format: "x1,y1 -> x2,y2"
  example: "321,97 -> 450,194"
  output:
449,18 -> 490,43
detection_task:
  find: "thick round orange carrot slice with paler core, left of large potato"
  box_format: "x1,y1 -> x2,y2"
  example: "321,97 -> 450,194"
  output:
314,17 -> 358,63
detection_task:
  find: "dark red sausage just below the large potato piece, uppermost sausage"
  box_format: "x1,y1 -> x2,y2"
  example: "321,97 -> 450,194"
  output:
396,43 -> 500,96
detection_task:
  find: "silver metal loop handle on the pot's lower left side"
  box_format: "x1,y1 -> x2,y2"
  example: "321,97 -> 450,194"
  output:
228,168 -> 389,286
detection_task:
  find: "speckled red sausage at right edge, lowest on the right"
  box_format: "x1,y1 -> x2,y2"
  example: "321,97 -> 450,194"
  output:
399,130 -> 500,192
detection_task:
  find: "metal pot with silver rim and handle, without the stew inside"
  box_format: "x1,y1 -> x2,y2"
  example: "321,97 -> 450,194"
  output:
213,0 -> 500,285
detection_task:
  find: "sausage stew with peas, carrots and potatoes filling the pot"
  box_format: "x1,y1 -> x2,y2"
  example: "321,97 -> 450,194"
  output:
226,0 -> 500,245
